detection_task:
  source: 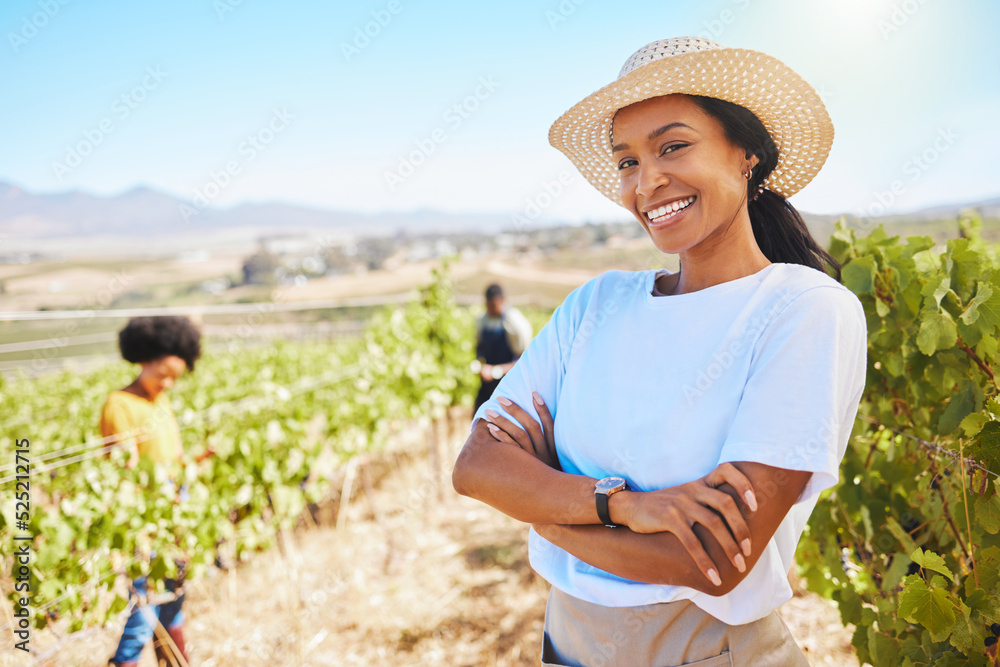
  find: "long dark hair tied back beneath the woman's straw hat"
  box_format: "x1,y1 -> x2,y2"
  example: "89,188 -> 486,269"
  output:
690,95 -> 840,281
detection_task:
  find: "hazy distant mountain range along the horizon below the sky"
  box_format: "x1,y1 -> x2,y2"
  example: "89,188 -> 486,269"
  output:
0,182 -> 1000,252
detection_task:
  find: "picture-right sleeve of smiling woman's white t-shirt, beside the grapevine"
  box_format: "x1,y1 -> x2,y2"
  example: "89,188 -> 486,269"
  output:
719,286 -> 868,502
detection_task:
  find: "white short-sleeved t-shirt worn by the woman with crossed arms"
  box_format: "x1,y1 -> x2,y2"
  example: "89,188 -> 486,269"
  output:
473,263 -> 867,625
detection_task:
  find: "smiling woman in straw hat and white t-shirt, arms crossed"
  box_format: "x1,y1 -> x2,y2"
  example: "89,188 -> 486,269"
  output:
453,37 -> 867,666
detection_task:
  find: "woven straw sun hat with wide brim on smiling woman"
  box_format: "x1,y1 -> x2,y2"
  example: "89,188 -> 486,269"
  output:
549,37 -> 833,205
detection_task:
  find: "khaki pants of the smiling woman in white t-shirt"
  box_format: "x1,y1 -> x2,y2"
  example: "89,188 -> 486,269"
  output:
542,587 -> 809,667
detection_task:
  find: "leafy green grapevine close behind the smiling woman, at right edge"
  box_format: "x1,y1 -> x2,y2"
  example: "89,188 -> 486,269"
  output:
798,215 -> 1000,667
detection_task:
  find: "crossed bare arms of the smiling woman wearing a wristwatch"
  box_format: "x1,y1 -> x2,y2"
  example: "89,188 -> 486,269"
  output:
452,394 -> 812,595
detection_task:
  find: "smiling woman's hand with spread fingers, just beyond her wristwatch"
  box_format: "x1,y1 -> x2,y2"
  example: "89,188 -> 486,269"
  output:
612,463 -> 757,586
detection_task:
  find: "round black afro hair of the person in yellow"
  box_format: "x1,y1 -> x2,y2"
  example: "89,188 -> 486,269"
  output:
118,315 -> 201,371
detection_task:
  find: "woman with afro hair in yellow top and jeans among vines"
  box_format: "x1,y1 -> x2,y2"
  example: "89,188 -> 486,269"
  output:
101,317 -> 206,667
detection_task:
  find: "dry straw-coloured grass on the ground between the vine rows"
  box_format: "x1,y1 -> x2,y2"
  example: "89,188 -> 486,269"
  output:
0,414 -> 857,667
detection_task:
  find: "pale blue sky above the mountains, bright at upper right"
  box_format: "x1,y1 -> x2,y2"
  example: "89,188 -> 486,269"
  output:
0,0 -> 1000,221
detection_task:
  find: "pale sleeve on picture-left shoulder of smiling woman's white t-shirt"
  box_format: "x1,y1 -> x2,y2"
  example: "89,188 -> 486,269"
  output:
472,283 -> 589,436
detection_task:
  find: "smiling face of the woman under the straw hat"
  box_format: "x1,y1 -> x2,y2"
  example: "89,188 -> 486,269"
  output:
612,95 -> 757,253
